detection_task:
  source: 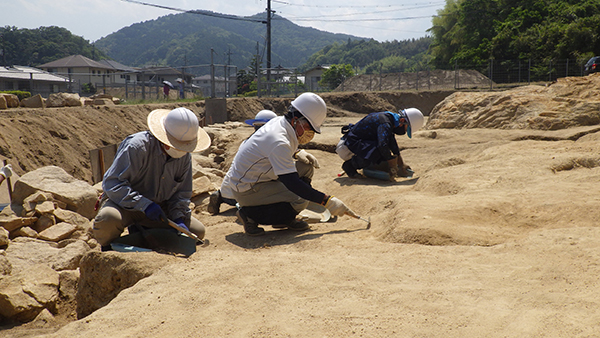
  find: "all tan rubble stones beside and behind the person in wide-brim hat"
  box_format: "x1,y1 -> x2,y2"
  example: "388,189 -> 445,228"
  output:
0,122 -> 246,324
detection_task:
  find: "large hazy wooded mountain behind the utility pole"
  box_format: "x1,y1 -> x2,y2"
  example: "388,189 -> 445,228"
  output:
95,12 -> 359,69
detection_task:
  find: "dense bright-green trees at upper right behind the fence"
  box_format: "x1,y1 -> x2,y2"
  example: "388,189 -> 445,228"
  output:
430,0 -> 600,67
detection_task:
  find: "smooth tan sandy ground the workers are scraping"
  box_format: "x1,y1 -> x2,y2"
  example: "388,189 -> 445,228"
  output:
0,96 -> 600,338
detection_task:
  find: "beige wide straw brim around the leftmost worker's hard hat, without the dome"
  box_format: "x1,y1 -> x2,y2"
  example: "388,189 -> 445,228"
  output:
148,109 -> 210,153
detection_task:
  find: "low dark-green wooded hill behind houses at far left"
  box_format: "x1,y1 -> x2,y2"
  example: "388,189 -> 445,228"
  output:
0,26 -> 107,66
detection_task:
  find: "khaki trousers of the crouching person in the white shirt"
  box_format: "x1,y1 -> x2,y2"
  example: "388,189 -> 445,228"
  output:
233,161 -> 315,212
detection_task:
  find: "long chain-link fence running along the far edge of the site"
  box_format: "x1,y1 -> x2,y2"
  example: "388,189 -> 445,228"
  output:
22,59 -> 585,100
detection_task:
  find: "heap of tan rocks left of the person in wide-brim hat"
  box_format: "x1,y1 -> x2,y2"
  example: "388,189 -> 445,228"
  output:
0,166 -> 98,322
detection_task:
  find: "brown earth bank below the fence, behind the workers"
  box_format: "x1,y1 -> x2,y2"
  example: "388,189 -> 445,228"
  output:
0,92 -> 450,182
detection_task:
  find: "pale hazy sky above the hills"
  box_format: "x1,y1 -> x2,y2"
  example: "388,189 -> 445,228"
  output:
0,0 -> 445,42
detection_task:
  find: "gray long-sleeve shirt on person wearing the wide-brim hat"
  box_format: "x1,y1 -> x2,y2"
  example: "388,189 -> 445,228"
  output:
102,131 -> 192,220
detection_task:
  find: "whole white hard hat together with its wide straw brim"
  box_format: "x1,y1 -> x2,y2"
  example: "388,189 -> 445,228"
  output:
148,107 -> 210,152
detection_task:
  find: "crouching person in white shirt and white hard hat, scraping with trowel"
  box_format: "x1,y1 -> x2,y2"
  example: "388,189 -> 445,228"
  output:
226,93 -> 358,236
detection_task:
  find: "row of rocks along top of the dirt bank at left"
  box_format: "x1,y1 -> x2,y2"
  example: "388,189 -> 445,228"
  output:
0,93 -> 121,109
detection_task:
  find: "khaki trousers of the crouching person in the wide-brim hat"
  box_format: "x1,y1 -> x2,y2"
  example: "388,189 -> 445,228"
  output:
92,200 -> 206,246
